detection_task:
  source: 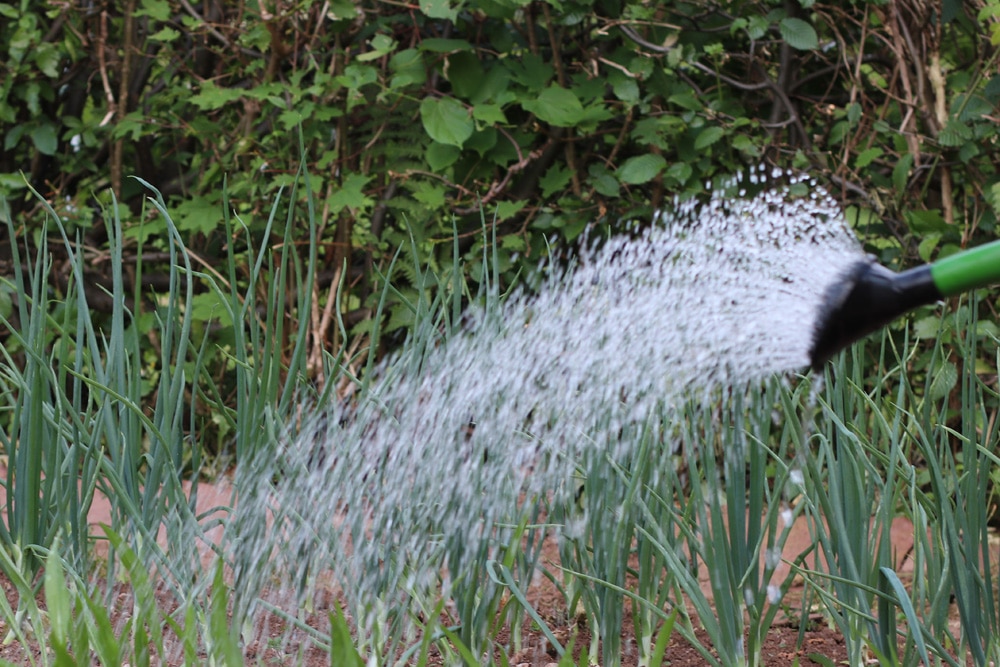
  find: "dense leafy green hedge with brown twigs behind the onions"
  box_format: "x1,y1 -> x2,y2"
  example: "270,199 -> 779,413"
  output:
0,0 -> 1000,362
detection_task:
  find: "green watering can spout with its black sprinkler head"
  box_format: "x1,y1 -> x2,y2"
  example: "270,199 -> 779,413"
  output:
809,241 -> 1000,370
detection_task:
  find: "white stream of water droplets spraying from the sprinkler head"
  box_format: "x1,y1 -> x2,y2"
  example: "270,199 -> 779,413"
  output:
227,170 -> 863,652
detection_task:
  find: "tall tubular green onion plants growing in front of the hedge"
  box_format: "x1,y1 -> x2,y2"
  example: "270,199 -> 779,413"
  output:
0,173 -> 1000,667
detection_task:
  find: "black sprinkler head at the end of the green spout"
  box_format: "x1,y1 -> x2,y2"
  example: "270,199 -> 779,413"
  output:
809,258 -> 943,371
